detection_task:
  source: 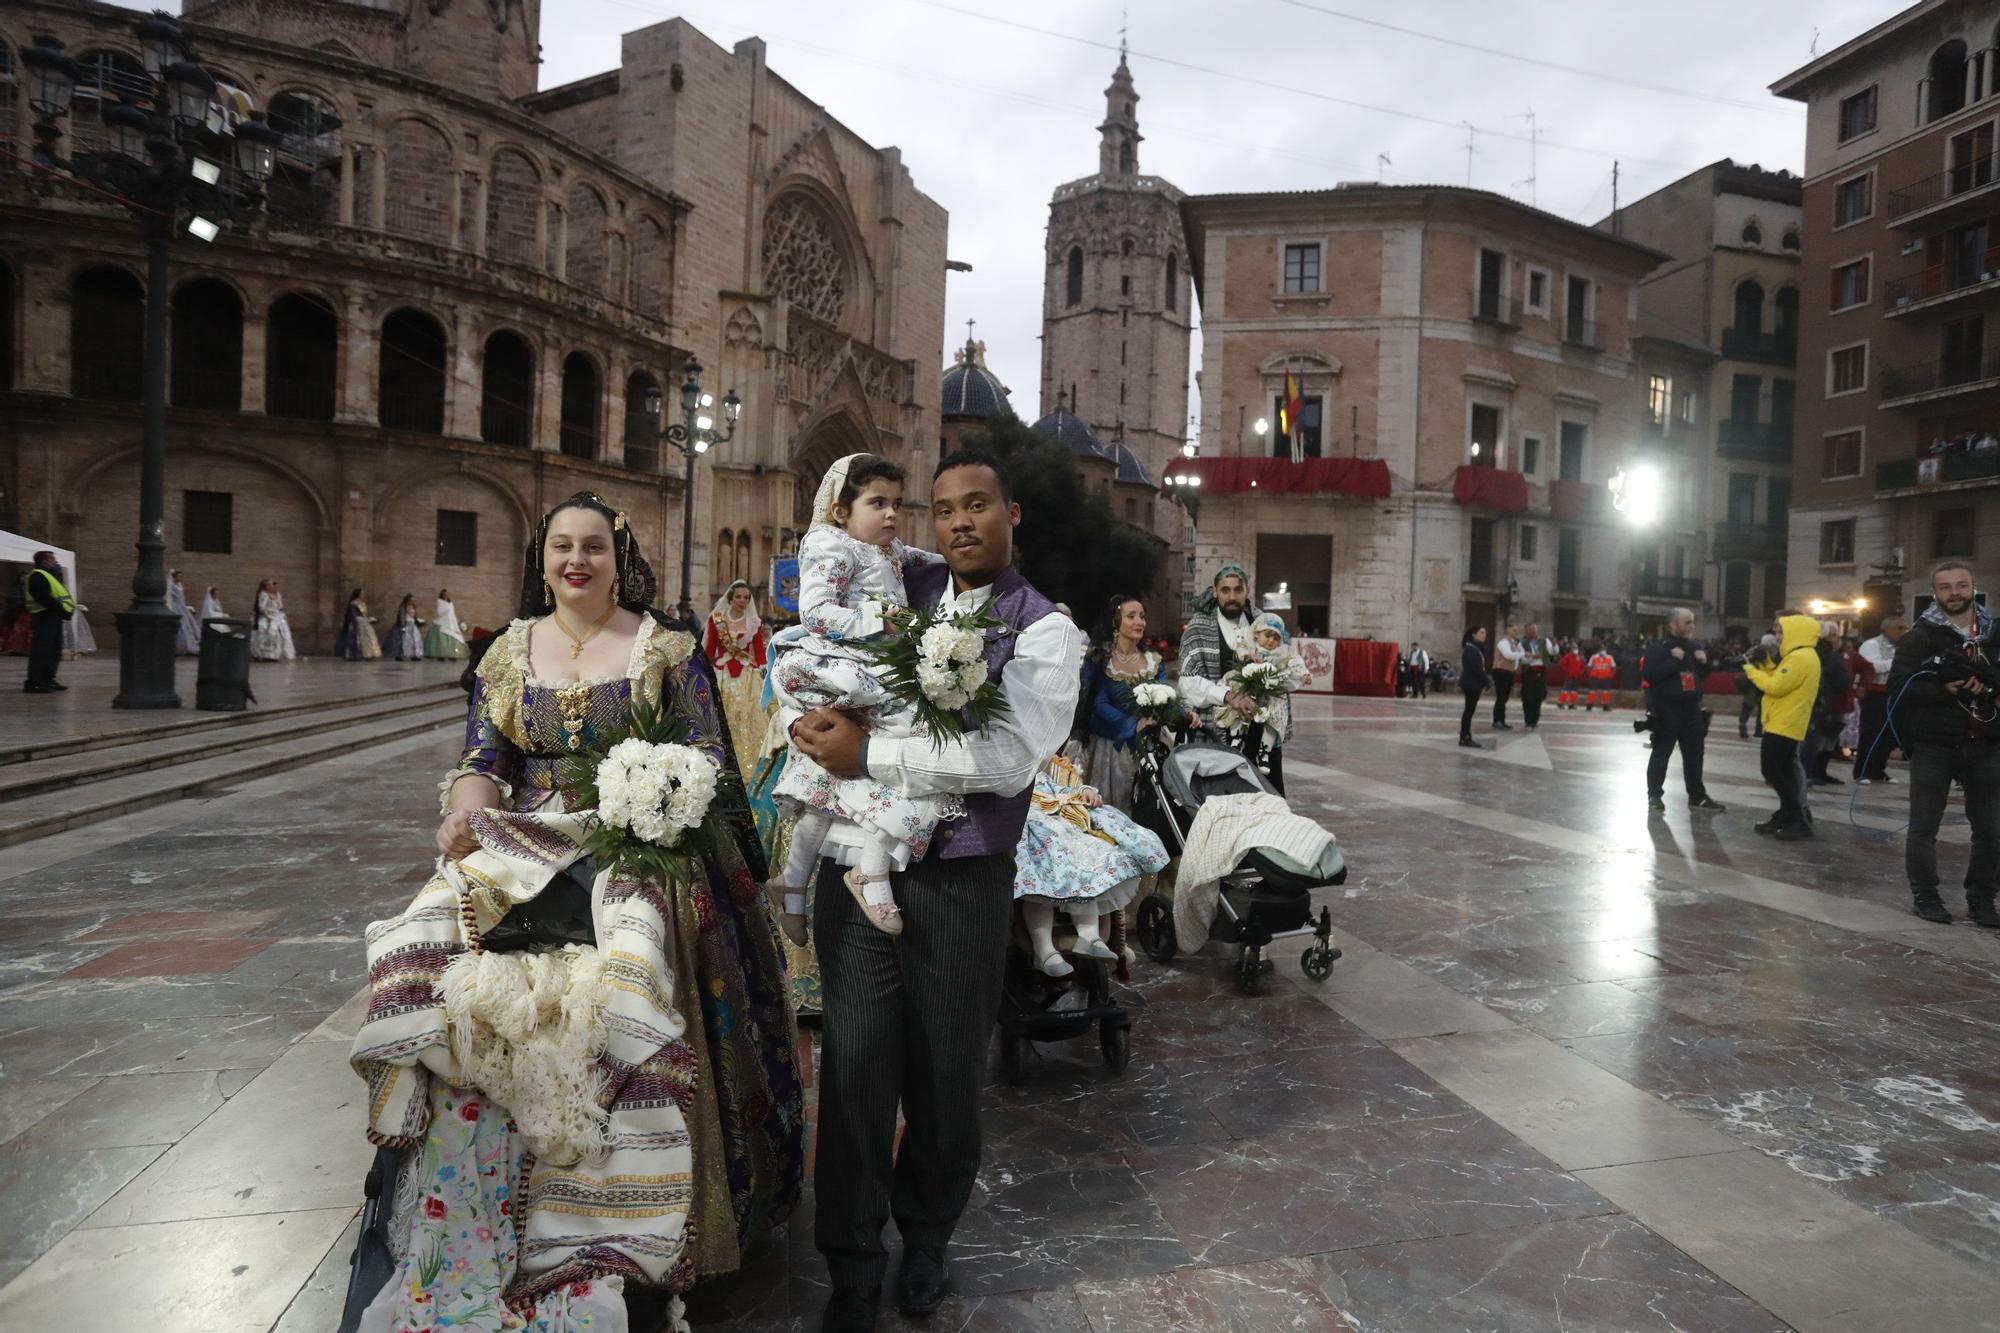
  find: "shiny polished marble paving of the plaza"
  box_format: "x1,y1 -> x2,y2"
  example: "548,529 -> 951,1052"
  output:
0,699 -> 2000,1333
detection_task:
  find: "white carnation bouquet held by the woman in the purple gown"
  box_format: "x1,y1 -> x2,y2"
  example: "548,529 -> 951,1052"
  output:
564,705 -> 722,879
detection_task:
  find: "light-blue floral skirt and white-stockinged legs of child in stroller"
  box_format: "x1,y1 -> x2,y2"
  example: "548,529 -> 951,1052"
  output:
1014,755 -> 1166,977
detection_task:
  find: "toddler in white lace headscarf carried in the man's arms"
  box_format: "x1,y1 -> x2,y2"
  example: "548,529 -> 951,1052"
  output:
766,454 -> 960,945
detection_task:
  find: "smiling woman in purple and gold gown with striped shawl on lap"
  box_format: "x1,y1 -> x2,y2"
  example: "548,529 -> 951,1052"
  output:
354,494 -> 804,1333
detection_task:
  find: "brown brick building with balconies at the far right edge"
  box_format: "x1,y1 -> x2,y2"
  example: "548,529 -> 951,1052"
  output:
1772,0 -> 2000,628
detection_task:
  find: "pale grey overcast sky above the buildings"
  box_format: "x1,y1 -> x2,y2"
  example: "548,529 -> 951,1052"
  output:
134,0 -> 1904,418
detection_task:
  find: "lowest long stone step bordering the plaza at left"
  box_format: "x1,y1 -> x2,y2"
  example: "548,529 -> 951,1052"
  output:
0,691 -> 466,847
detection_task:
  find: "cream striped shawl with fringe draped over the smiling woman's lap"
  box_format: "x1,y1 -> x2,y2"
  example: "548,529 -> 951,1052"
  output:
350,811 -> 700,1299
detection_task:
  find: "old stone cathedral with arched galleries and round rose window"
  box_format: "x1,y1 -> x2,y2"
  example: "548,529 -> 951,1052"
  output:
0,0 -> 946,652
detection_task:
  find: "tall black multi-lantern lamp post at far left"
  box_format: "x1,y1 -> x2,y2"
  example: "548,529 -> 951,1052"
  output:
22,14 -> 278,709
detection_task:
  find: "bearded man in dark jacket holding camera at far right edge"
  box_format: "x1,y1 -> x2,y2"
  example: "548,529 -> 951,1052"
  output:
1888,560 -> 2000,929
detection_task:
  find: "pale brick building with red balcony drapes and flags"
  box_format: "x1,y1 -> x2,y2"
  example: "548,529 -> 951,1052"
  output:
1174,184 -> 1664,652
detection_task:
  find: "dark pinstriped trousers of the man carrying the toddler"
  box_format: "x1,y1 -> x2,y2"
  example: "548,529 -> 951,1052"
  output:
812,853 -> 1014,1291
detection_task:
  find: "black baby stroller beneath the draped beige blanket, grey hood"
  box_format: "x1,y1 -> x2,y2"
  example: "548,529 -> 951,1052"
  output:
1134,739 -> 1348,993
